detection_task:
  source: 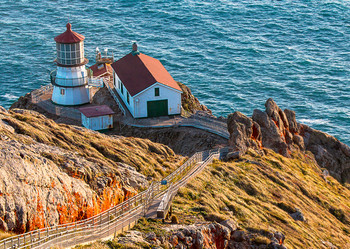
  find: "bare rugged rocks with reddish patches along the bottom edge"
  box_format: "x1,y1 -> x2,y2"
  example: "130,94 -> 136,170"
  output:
116,221 -> 286,249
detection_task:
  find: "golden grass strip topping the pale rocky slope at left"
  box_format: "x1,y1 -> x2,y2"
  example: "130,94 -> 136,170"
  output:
0,111 -> 184,183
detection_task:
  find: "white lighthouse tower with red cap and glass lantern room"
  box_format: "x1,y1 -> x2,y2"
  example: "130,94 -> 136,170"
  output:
50,23 -> 90,106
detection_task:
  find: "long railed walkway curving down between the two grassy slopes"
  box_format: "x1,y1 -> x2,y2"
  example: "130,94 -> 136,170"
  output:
0,147 -> 227,249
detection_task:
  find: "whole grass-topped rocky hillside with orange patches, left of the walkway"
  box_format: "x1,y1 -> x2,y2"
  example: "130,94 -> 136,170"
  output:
0,108 -> 183,232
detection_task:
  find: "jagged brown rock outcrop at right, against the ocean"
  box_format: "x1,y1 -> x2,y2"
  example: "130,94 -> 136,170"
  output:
227,99 -> 350,183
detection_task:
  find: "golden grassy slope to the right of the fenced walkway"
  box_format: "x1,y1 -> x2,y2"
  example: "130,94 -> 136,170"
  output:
173,150 -> 350,248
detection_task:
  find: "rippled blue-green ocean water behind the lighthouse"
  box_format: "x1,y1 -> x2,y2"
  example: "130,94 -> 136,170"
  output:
0,0 -> 350,145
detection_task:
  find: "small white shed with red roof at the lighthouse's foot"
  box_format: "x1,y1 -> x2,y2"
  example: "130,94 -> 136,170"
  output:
79,105 -> 114,131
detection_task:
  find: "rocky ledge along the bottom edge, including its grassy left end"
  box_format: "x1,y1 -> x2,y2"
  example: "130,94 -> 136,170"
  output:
77,220 -> 286,249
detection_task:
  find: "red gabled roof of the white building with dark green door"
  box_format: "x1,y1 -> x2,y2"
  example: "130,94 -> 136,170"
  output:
112,53 -> 181,96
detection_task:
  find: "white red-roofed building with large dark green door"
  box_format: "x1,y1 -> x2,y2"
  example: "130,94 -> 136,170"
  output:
112,43 -> 182,118
